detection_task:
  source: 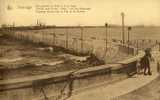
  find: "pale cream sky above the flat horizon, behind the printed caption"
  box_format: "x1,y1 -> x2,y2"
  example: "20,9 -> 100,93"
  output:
0,0 -> 160,26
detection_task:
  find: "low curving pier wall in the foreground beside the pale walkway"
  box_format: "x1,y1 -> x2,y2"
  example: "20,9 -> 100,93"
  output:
0,54 -> 143,100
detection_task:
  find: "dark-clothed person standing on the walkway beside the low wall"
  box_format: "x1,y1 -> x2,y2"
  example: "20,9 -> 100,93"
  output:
140,48 -> 153,75
